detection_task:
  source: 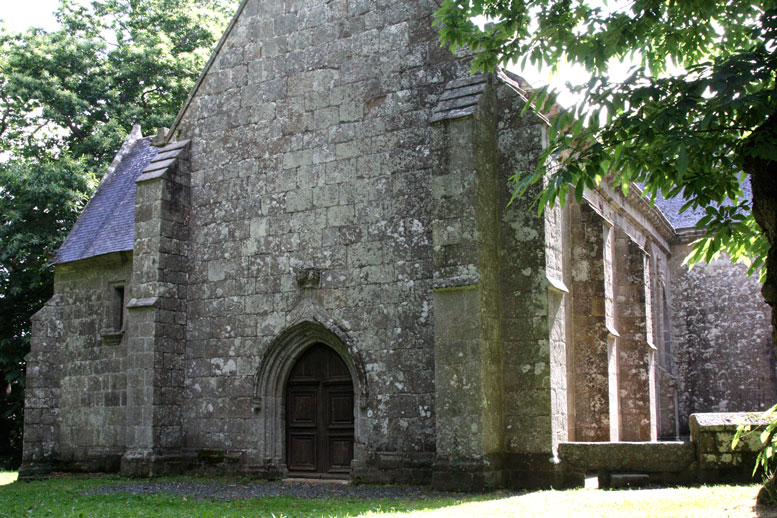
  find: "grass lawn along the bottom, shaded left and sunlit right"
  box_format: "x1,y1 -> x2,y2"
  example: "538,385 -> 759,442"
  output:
0,478 -> 777,518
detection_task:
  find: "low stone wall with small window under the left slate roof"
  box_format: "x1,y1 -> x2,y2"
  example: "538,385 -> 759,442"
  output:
39,252 -> 132,471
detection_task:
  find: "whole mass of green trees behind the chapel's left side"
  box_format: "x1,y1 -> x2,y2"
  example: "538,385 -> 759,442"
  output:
0,0 -> 236,468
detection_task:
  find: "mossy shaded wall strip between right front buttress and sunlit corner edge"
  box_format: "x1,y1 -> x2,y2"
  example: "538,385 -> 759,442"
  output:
495,84 -> 566,487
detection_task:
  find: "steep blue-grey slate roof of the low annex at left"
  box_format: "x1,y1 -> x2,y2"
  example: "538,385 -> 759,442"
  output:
54,134 -> 158,264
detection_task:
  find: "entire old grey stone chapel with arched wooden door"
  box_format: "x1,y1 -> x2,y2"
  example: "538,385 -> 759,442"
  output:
22,0 -> 777,487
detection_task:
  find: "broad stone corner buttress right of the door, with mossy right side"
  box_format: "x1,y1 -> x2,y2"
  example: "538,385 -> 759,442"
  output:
432,74 -> 566,487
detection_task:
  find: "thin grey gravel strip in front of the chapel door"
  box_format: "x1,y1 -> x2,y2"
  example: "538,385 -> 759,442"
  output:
86,480 -> 470,500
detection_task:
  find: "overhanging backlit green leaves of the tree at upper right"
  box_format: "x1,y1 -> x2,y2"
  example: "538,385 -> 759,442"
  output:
436,0 -> 777,278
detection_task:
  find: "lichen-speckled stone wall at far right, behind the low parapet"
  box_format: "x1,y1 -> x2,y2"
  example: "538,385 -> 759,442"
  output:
670,244 -> 777,434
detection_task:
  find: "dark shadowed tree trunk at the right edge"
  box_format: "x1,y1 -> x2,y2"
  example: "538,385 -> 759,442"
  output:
739,115 -> 777,344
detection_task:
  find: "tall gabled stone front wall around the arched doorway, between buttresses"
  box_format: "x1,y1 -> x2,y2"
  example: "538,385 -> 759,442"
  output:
171,0 -> 476,478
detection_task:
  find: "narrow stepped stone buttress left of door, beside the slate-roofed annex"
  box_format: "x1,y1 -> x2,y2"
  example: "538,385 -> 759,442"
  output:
121,141 -> 190,476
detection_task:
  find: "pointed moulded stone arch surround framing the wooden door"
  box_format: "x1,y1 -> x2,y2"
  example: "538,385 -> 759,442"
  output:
253,321 -> 367,475
